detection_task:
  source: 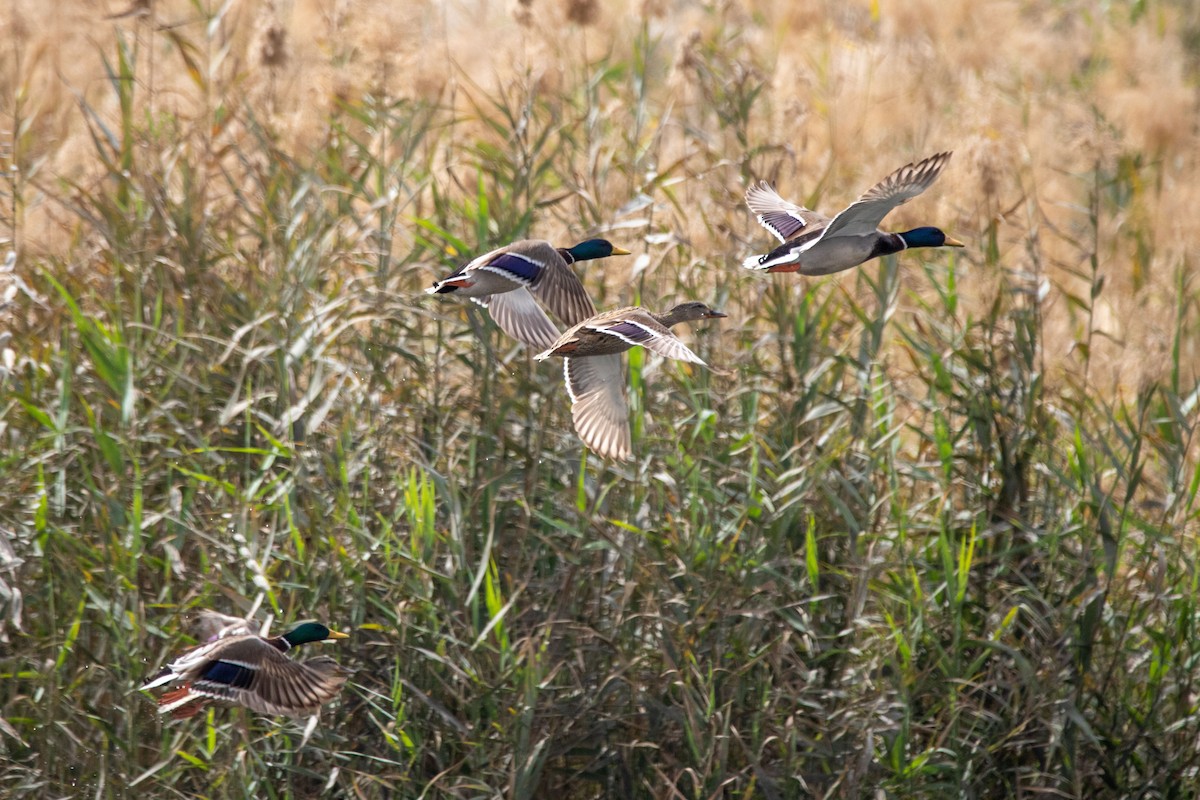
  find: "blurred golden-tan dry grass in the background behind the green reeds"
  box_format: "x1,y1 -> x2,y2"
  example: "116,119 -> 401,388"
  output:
0,0 -> 1200,391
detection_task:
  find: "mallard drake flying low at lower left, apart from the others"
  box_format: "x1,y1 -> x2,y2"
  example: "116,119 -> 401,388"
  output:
140,618 -> 349,718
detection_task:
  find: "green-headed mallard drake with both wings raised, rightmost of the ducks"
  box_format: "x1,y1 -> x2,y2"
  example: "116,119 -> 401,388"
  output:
742,152 -> 962,275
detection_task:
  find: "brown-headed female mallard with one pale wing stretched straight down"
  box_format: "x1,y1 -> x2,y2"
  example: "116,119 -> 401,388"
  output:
534,302 -> 726,461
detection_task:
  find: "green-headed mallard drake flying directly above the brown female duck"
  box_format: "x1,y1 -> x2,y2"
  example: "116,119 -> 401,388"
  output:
426,239 -> 629,348
